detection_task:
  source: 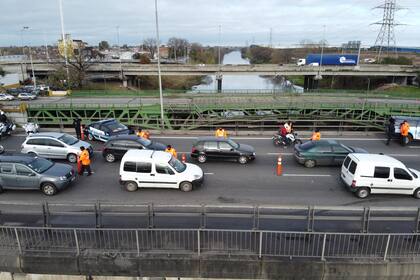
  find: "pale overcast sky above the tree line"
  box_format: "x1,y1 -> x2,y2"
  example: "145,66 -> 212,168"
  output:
0,0 -> 420,46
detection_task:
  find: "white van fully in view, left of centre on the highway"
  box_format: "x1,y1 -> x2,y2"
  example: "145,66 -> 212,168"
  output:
120,150 -> 204,192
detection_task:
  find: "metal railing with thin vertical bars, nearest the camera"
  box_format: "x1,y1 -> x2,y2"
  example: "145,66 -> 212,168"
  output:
0,227 -> 420,261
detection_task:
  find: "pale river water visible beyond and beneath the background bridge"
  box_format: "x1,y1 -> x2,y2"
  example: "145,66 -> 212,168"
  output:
193,51 -> 299,92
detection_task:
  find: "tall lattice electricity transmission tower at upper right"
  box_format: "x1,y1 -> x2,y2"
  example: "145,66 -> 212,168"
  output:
373,0 -> 401,60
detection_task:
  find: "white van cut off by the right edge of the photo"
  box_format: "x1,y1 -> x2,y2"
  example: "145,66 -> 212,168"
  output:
341,153 -> 420,198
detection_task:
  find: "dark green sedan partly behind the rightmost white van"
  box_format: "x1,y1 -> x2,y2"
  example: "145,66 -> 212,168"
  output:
294,140 -> 367,168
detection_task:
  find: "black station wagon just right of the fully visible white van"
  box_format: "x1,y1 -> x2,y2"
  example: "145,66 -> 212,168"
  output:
191,137 -> 255,164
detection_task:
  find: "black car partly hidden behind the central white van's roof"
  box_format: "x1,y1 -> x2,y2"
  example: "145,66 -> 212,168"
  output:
102,135 -> 166,162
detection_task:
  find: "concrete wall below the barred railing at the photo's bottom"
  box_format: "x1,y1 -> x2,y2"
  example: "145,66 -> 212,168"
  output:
0,253 -> 420,280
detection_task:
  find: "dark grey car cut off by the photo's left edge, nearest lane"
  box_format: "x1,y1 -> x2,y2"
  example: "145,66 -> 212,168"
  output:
0,153 -> 76,195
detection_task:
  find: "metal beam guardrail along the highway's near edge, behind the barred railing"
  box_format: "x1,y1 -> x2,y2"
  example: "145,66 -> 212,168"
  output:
0,202 -> 420,233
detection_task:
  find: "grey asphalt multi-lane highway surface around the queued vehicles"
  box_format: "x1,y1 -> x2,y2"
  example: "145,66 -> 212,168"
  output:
0,130 -> 420,206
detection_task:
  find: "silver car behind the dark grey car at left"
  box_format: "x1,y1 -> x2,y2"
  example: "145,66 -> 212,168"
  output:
21,132 -> 93,163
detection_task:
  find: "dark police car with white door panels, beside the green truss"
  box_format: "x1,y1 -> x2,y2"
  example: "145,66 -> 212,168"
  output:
84,119 -> 130,142
